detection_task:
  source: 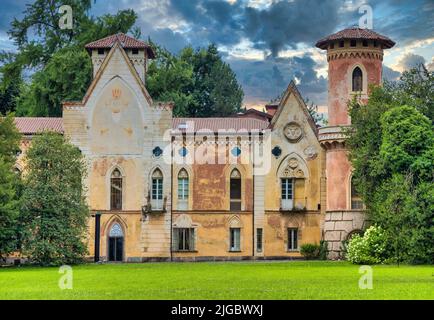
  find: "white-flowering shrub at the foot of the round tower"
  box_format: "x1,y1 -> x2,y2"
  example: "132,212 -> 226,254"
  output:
347,226 -> 387,264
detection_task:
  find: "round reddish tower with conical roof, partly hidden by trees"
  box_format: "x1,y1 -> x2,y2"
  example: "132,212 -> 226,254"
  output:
316,28 -> 395,259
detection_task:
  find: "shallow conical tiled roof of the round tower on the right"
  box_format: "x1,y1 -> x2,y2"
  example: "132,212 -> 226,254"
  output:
316,27 -> 395,49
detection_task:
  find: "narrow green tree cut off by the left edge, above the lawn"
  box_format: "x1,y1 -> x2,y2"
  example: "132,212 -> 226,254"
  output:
0,114 -> 20,259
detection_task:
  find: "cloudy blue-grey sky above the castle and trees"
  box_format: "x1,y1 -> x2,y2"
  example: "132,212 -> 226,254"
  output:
0,0 -> 434,111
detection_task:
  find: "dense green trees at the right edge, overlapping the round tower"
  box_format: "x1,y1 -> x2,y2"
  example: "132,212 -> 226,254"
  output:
347,68 -> 434,263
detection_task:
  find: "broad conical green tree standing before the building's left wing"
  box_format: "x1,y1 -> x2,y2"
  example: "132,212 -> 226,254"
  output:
21,132 -> 89,265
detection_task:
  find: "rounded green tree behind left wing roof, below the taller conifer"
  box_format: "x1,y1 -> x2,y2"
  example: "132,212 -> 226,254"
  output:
17,49 -> 92,117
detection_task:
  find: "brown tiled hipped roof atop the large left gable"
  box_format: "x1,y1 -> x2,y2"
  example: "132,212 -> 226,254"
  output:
85,33 -> 155,59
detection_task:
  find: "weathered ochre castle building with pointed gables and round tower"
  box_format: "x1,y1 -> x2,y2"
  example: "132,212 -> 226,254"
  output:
11,29 -> 393,262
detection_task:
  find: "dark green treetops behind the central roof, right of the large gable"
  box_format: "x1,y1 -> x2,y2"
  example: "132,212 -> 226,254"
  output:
147,44 -> 244,117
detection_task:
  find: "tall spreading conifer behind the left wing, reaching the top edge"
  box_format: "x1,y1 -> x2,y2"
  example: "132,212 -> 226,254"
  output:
0,0 -> 139,116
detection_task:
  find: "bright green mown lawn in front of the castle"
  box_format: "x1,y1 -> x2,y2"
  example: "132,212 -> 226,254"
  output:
0,261 -> 434,300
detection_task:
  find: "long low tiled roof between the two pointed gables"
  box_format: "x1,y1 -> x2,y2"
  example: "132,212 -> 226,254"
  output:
172,117 -> 269,133
